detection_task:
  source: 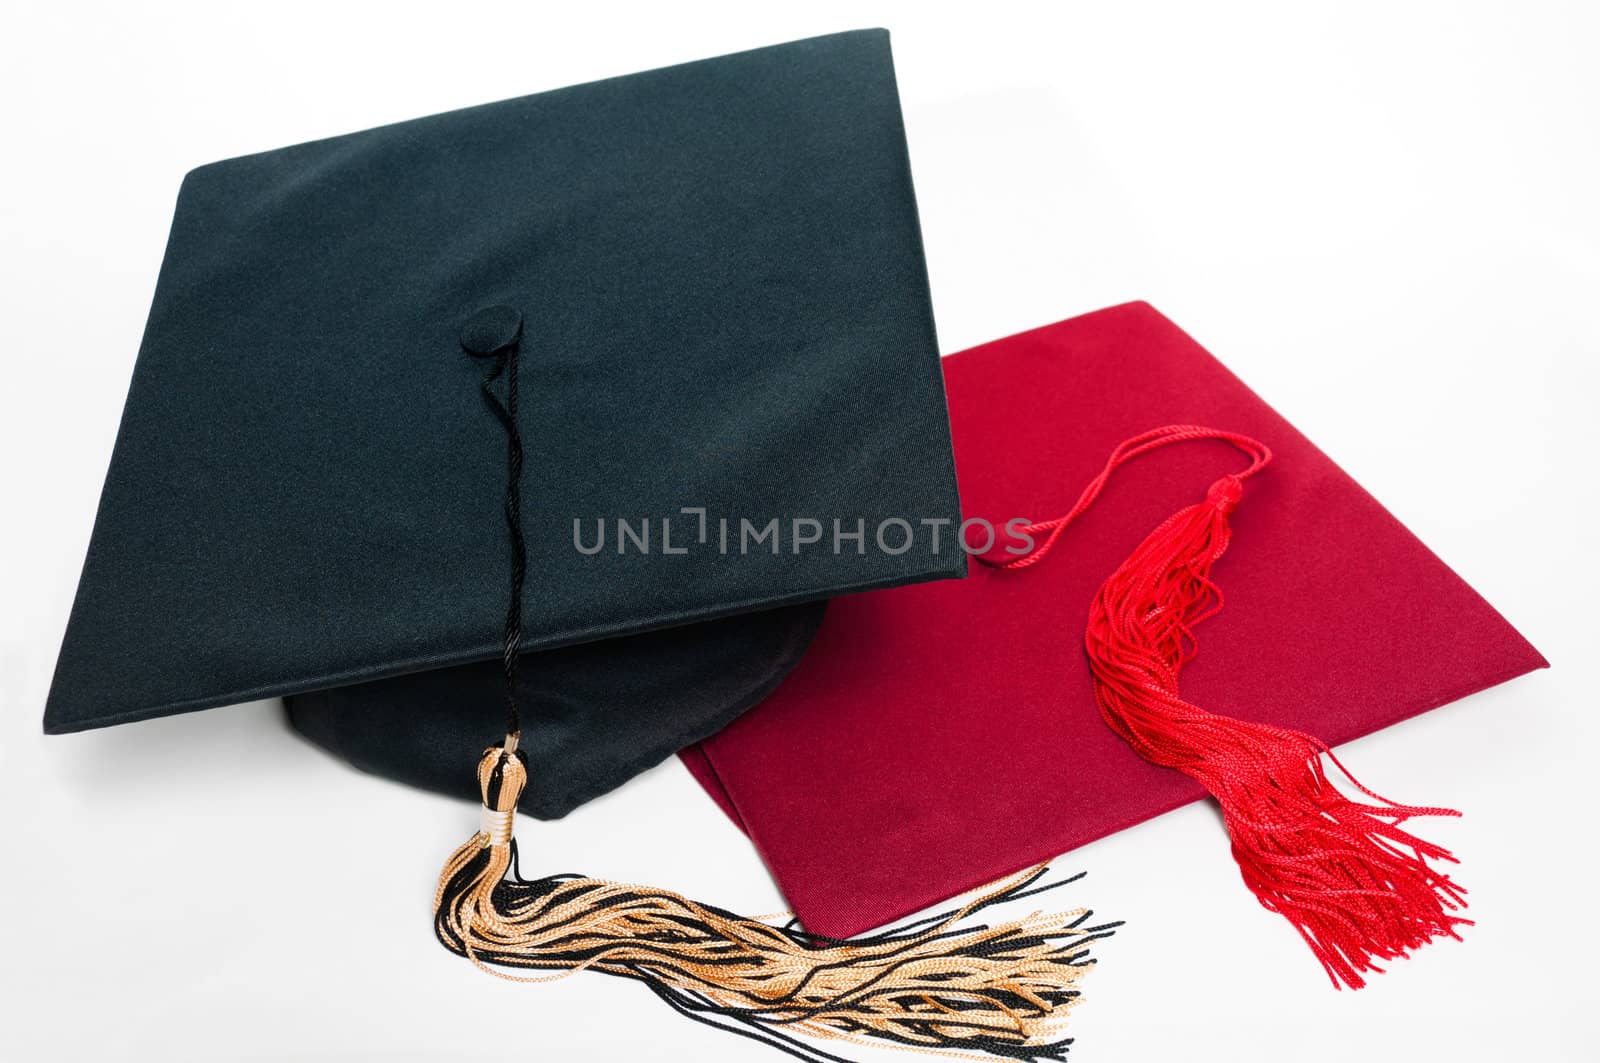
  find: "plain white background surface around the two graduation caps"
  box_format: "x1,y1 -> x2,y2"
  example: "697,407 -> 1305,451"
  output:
0,0 -> 1600,1063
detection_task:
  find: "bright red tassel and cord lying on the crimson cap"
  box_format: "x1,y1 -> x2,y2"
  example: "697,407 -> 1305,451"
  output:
989,424 -> 1470,989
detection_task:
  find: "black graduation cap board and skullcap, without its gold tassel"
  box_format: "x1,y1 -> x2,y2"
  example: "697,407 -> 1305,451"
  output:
45,30 -> 963,815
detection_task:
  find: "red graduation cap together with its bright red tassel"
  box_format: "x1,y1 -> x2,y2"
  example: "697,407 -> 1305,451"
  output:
683,304 -> 1546,985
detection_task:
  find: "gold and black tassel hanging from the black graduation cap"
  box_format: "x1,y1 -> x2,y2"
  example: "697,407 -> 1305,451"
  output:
434,735 -> 1118,1060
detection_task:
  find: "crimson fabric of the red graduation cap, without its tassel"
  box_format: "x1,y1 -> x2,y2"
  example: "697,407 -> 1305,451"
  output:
683,303 -> 1546,937
